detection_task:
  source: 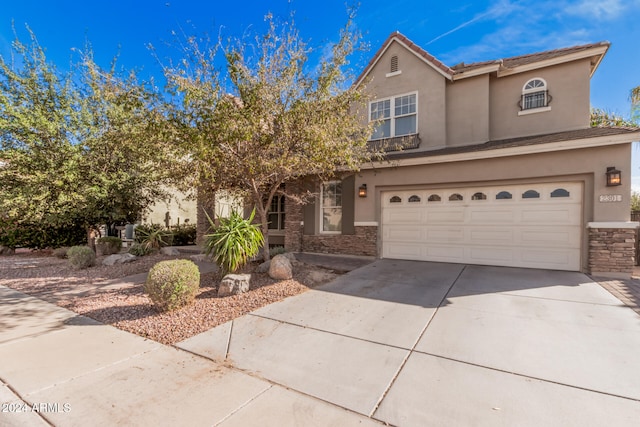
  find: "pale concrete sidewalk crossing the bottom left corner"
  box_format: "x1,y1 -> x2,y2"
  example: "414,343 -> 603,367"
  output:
0,287 -> 379,427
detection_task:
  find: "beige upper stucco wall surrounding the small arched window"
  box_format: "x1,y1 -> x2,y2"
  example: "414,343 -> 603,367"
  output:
489,59 -> 590,140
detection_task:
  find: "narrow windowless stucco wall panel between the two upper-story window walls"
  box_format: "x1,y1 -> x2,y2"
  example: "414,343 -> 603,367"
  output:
447,74 -> 489,147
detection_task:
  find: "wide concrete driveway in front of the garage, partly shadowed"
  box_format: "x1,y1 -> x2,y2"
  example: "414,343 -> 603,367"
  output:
178,260 -> 640,426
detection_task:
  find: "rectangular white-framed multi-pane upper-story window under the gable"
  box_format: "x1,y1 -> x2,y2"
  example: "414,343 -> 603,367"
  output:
369,93 -> 418,140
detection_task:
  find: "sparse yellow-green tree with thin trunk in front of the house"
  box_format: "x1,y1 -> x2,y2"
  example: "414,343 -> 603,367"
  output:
165,13 -> 371,259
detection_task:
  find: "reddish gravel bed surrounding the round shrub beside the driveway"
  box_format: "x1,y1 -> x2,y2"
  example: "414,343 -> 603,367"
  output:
0,252 -> 340,344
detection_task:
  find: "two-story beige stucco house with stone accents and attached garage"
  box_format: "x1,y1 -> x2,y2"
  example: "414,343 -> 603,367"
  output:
278,33 -> 640,276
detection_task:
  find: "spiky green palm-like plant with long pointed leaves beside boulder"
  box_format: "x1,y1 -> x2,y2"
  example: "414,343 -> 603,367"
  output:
204,209 -> 264,274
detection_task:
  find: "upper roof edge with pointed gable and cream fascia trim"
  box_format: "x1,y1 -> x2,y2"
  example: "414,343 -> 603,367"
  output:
355,31 -> 611,86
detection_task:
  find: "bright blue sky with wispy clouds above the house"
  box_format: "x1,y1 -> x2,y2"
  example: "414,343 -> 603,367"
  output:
0,0 -> 640,189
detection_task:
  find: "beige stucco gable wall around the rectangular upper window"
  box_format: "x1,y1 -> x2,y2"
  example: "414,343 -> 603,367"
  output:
367,42 -> 446,150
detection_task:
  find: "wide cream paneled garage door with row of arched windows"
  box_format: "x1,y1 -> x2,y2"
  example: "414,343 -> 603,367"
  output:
382,182 -> 582,271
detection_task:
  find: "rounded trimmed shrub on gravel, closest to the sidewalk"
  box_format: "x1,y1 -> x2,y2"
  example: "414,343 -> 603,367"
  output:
144,259 -> 200,311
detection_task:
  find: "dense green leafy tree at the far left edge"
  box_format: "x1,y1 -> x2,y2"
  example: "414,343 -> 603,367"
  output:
0,27 -> 180,247
